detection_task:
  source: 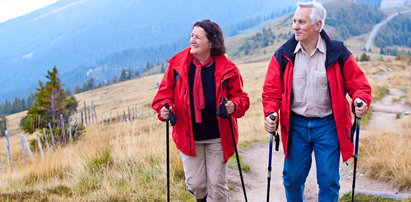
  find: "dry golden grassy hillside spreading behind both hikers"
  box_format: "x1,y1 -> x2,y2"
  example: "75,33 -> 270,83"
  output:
0,5 -> 411,201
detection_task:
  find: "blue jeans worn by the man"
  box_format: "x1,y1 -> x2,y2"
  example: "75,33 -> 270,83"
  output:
283,113 -> 340,202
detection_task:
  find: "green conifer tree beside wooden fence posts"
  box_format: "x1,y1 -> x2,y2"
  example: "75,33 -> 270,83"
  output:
20,66 -> 77,133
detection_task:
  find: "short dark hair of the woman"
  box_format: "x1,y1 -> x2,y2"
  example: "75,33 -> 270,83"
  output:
193,20 -> 225,56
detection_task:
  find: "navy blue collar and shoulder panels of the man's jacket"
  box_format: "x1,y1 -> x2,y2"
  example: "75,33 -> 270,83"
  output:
279,30 -> 344,68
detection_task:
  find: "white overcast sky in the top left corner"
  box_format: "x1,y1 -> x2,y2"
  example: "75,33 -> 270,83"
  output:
0,0 -> 57,23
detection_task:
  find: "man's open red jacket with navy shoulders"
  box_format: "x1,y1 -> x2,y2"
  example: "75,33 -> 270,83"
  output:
262,30 -> 372,162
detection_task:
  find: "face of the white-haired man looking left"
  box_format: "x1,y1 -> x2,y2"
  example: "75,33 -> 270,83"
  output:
293,7 -> 321,43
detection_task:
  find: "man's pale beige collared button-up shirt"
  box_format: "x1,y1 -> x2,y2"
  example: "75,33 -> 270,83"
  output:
291,36 -> 332,117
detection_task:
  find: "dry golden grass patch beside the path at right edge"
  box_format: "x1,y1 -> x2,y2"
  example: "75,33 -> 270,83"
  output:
359,117 -> 411,190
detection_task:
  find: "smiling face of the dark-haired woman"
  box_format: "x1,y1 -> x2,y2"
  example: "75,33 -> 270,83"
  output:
190,26 -> 211,61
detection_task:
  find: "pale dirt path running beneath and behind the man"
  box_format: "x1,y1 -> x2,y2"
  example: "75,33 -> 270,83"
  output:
228,88 -> 411,202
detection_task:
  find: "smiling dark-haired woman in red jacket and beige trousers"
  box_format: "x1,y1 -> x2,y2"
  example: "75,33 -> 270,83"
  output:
152,20 -> 249,201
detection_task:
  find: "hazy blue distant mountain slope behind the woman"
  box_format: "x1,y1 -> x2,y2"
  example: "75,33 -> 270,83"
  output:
0,0 -> 296,102
